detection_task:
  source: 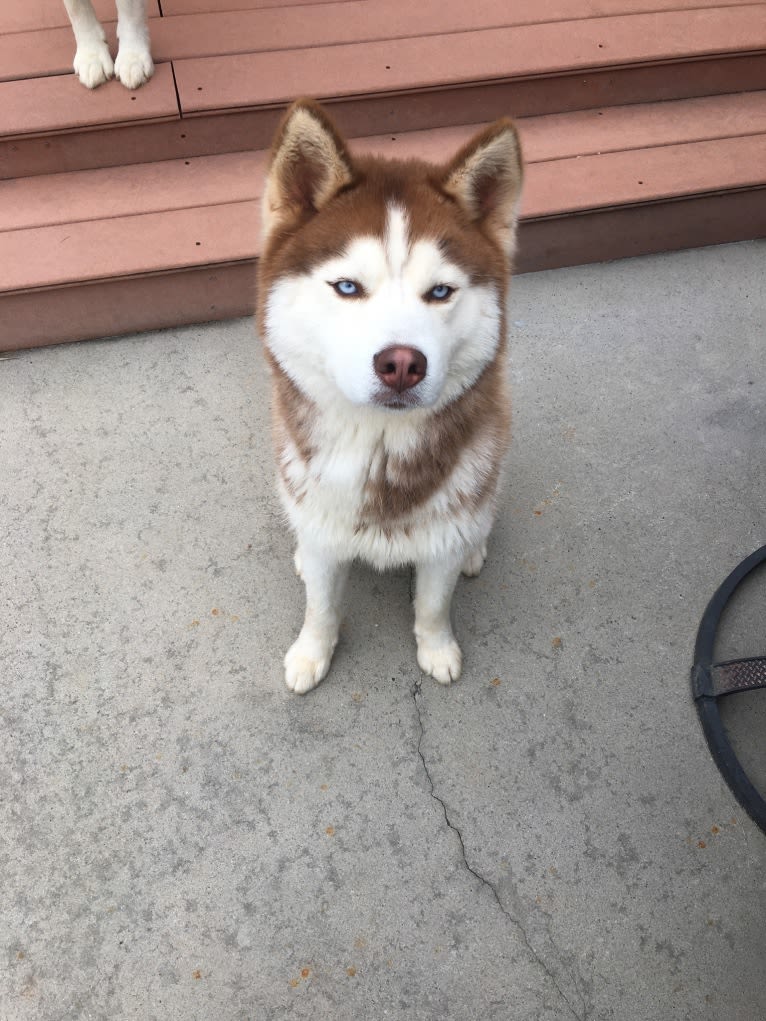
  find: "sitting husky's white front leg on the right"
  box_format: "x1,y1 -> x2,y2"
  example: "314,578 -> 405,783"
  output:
415,557 -> 463,684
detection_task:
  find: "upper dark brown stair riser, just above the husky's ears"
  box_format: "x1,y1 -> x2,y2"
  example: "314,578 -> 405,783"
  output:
0,54 -> 766,180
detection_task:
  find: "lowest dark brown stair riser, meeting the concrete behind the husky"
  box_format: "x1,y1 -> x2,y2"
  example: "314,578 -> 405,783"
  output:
0,189 -> 766,350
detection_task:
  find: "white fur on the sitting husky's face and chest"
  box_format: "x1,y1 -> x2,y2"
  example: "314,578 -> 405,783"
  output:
266,203 -> 502,569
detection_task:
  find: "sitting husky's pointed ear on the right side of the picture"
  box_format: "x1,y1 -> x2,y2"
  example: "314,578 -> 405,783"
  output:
441,117 -> 524,255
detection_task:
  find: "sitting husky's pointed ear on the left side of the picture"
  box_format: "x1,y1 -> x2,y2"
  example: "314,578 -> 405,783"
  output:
264,99 -> 353,237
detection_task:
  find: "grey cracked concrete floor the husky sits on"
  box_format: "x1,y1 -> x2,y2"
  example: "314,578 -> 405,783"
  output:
0,242 -> 766,1021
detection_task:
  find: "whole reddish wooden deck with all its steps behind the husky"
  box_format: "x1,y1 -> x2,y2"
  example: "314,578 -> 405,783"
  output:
0,0 -> 766,349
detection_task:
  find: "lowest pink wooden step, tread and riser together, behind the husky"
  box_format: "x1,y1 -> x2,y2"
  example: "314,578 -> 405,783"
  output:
0,93 -> 766,347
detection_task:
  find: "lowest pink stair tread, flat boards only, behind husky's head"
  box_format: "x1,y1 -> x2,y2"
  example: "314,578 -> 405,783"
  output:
0,92 -> 766,291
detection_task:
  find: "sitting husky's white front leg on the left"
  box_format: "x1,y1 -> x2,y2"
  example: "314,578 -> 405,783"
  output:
285,542 -> 348,695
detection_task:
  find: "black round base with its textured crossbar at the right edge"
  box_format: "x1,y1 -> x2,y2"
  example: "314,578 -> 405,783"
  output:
691,546 -> 766,833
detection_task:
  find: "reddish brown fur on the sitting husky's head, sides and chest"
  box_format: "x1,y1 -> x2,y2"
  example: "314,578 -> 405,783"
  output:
257,103 -> 522,530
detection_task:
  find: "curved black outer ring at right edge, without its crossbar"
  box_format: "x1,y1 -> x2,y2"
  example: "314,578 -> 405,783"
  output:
691,546 -> 766,833
